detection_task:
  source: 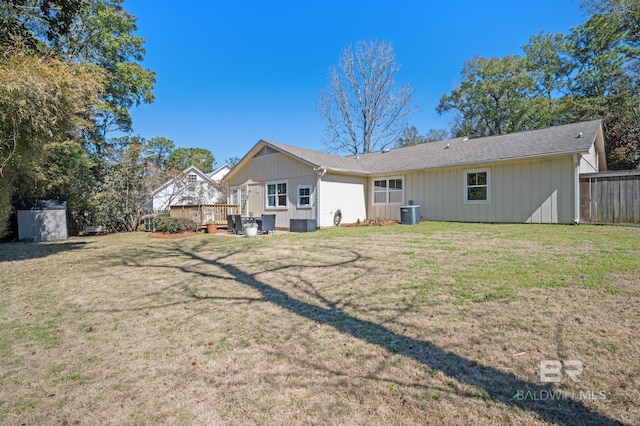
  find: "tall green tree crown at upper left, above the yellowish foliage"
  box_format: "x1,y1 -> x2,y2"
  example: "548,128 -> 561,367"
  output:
0,0 -> 155,143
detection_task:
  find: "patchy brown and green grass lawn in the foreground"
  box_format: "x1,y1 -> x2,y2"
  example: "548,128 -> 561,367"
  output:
0,222 -> 640,425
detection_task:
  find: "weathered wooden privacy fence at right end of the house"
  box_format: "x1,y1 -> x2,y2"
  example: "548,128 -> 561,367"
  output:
580,170 -> 640,224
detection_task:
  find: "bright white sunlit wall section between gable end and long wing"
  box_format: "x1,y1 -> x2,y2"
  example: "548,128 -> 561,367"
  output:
318,173 -> 368,227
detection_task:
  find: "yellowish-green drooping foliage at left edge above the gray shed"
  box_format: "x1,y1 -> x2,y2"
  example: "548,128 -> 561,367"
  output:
0,46 -> 102,238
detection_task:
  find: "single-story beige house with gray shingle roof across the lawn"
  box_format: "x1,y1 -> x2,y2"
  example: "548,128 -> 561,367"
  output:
225,120 -> 606,228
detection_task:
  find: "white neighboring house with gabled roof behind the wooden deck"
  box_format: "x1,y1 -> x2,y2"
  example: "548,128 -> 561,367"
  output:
151,163 -> 231,212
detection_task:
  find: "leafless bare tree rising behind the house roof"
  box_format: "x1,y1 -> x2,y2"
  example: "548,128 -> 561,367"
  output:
317,40 -> 415,154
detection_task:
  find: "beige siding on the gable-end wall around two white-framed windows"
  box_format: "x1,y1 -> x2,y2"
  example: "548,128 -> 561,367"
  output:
227,150 -> 317,228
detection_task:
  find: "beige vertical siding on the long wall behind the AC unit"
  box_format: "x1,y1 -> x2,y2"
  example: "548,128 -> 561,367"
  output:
368,156 -> 575,223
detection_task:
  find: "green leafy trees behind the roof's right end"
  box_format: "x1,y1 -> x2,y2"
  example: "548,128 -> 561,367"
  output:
436,5 -> 640,168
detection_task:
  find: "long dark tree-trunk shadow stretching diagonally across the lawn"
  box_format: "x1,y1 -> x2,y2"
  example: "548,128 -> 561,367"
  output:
142,243 -> 623,425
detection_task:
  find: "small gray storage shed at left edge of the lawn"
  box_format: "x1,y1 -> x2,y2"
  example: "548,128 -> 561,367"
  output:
16,200 -> 68,241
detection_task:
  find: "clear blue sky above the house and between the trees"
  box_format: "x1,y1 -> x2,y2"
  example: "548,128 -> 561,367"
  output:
124,0 -> 585,165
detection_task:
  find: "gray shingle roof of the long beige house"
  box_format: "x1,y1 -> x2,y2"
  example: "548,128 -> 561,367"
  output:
262,120 -> 601,174
